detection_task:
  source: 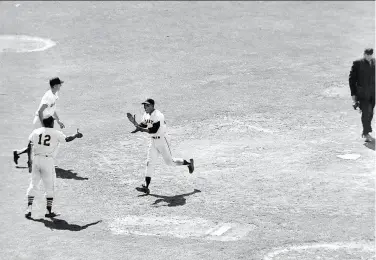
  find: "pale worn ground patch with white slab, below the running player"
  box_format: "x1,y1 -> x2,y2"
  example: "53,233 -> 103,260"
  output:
109,216 -> 256,241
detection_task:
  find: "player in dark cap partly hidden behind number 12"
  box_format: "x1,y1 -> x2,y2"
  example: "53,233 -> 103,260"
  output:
13,78 -> 65,172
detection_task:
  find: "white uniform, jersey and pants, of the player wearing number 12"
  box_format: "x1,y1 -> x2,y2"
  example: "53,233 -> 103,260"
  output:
27,127 -> 66,198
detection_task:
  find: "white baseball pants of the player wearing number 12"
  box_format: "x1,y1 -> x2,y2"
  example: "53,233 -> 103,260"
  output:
27,155 -> 56,198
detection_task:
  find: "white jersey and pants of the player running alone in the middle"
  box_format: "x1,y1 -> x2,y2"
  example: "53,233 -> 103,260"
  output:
141,109 -> 184,177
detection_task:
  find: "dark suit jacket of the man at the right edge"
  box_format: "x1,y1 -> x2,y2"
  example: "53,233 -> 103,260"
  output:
349,59 -> 375,99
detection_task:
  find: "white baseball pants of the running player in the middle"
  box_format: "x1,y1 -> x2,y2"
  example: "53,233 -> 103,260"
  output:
145,136 -> 184,177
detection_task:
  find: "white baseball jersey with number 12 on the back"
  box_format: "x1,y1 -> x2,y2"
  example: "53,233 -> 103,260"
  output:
29,127 -> 66,158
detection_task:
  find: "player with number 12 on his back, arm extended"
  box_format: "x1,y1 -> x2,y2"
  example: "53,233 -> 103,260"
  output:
25,116 -> 83,218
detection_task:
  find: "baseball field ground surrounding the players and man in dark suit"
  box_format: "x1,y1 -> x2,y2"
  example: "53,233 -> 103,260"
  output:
0,1 -> 375,260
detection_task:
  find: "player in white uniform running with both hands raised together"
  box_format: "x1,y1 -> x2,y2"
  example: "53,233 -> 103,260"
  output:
127,98 -> 194,194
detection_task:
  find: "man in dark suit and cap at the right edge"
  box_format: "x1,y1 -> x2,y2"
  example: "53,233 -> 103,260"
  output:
349,49 -> 375,142
